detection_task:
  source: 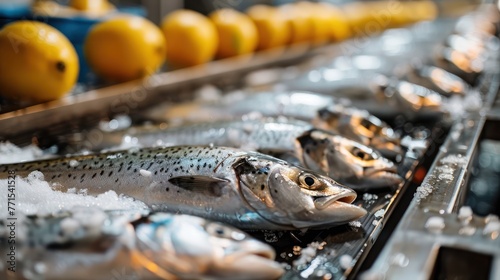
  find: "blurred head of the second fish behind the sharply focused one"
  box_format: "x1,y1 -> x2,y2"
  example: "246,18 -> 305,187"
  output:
312,104 -> 404,158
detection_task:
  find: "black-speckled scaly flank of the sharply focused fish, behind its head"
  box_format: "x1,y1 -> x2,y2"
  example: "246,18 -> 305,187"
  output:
2,147 -> 254,223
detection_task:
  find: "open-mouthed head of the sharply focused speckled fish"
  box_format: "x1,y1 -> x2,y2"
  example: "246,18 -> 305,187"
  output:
235,155 -> 366,229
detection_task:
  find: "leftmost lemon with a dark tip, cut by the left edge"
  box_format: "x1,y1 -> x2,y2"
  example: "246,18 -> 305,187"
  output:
0,20 -> 79,102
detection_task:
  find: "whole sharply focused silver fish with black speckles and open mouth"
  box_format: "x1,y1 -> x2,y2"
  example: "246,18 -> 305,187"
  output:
0,146 -> 366,230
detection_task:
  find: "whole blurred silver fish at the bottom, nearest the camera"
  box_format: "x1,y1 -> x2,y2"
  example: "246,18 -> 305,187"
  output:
0,207 -> 284,279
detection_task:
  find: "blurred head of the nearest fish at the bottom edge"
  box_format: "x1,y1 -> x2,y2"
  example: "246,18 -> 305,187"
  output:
136,213 -> 283,279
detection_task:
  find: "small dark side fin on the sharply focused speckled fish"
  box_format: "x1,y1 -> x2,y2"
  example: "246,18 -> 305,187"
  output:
168,175 -> 229,197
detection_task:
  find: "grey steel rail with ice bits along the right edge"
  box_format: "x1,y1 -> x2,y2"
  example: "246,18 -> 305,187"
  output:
365,69 -> 500,279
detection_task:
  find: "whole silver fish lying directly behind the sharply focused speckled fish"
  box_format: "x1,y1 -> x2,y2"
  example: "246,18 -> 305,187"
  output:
64,118 -> 400,190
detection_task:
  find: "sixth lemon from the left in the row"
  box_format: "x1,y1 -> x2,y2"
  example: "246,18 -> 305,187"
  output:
278,4 -> 312,44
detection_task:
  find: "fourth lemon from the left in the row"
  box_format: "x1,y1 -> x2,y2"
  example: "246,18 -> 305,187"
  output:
210,8 -> 258,58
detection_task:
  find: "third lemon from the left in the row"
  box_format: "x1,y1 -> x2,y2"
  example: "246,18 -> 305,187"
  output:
161,10 -> 218,67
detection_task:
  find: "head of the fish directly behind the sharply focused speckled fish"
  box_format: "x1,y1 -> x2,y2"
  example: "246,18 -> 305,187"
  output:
297,129 -> 403,190
